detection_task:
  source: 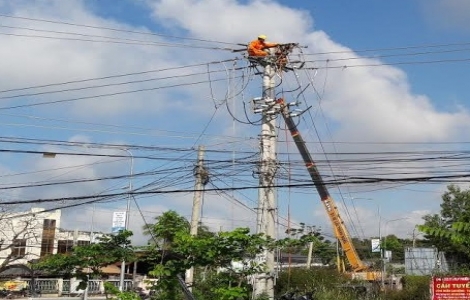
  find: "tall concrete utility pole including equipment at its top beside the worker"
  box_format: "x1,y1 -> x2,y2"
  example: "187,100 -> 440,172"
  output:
250,43 -> 304,299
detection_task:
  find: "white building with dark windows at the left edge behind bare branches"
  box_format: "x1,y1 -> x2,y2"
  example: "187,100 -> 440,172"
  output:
0,208 -> 92,270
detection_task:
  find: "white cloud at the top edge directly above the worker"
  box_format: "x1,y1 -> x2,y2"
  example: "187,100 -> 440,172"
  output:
148,0 -> 313,42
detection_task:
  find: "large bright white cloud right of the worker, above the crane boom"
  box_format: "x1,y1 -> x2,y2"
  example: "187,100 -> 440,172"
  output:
302,33 -> 470,142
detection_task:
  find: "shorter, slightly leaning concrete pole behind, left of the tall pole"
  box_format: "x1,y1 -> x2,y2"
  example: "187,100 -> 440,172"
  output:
186,146 -> 209,291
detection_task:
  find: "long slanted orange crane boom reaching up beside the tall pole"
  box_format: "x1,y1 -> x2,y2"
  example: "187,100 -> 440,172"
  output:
276,98 -> 382,282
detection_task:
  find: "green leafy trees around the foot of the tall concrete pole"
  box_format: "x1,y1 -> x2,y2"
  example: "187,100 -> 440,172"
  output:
145,211 -> 321,300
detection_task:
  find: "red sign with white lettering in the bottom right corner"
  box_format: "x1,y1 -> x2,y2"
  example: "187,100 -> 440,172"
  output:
431,276 -> 470,300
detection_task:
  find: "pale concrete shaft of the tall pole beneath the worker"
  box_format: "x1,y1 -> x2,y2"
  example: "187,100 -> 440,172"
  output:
254,63 -> 277,299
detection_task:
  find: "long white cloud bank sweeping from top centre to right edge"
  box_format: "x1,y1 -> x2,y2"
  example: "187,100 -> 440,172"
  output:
149,0 -> 470,147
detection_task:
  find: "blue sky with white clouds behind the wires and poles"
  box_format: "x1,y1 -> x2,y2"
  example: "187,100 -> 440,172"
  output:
0,0 -> 470,244
